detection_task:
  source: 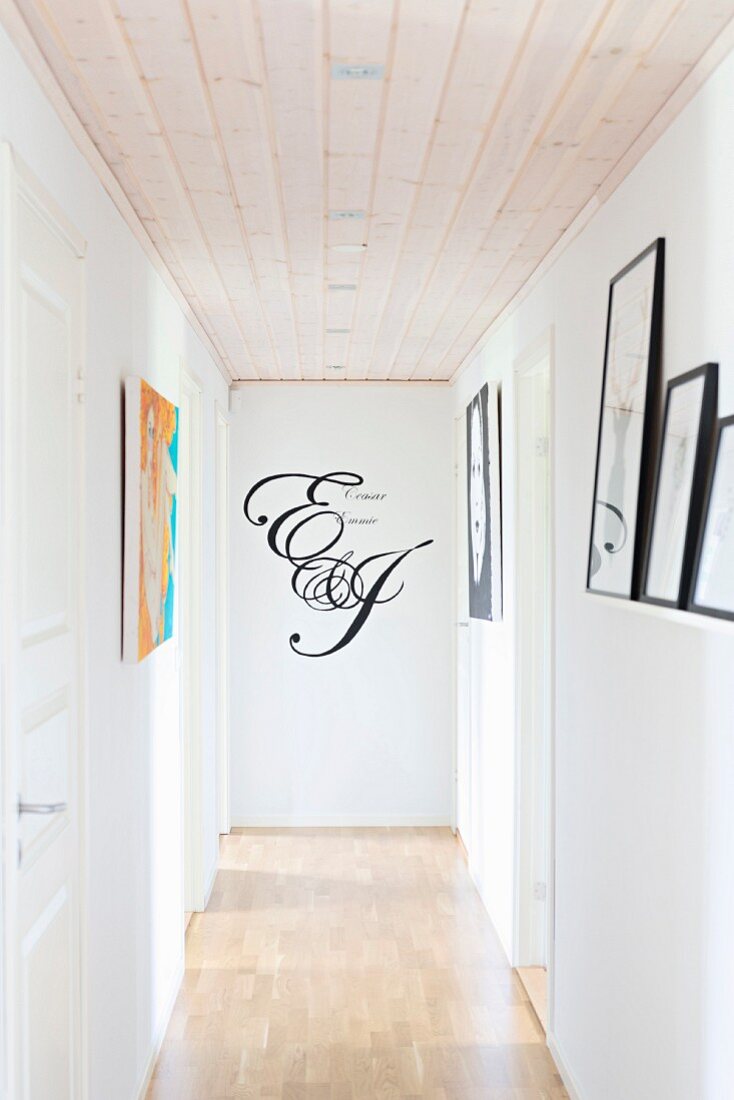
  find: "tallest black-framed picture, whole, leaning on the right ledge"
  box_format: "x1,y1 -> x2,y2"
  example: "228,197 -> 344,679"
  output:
587,238 -> 665,600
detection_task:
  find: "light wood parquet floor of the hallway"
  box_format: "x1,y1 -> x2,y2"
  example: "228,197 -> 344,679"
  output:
147,828 -> 567,1100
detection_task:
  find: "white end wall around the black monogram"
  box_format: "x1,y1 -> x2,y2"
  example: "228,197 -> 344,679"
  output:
230,383 -> 452,824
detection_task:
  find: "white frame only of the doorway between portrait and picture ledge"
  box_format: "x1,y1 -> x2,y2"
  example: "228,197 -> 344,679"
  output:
513,327 -> 556,1031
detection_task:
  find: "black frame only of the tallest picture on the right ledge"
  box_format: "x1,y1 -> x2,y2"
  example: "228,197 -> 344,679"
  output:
587,237 -> 665,600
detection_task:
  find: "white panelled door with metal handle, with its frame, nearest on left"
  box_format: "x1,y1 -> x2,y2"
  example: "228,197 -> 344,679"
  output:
2,150 -> 84,1100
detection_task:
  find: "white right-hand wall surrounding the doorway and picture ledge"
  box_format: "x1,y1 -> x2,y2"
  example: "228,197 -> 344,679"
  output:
454,47 -> 734,1100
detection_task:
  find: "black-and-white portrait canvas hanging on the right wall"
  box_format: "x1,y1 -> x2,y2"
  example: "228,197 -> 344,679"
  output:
467,384 -> 502,620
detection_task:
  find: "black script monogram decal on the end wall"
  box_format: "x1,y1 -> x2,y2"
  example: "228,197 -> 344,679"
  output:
243,471 -> 434,657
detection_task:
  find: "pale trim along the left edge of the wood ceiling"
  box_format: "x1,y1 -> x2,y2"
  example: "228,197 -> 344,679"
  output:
0,0 -> 234,387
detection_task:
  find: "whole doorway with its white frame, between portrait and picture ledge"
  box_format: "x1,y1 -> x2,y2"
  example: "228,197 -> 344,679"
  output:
514,334 -> 554,1031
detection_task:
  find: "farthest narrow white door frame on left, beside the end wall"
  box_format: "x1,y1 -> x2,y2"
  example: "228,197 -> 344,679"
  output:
215,404 -> 230,834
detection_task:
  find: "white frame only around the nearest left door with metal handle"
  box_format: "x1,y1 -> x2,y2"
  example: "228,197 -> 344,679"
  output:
0,142 -> 89,1100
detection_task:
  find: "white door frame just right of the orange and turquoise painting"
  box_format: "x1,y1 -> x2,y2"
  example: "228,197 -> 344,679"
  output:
177,362 -> 206,913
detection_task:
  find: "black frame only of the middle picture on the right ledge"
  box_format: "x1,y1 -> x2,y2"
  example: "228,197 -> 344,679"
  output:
639,363 -> 719,609
